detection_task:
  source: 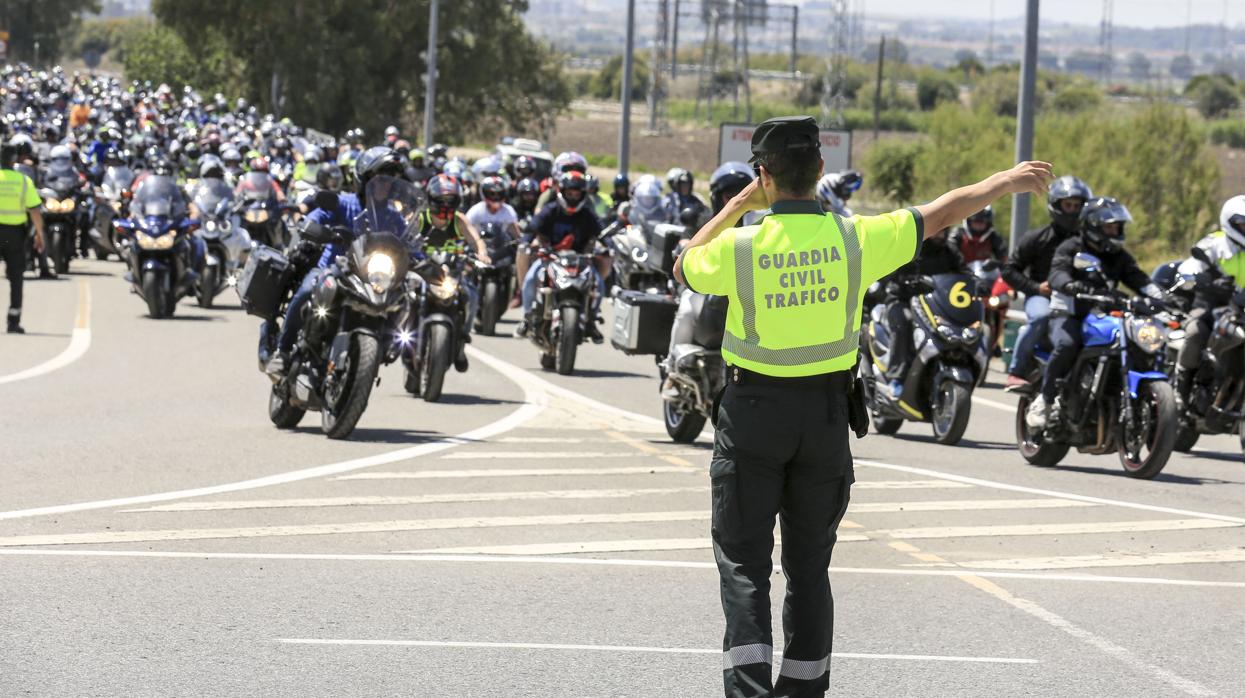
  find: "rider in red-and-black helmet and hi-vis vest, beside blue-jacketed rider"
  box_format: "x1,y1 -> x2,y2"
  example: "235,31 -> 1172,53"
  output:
420,174 -> 490,373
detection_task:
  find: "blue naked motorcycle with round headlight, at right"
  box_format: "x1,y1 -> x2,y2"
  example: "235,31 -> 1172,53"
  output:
1015,253 -> 1179,479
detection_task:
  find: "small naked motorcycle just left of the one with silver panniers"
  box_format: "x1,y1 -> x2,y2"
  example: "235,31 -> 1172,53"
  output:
530,250 -> 598,376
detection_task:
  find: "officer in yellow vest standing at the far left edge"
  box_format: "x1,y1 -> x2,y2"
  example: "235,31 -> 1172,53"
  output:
0,146 -> 44,335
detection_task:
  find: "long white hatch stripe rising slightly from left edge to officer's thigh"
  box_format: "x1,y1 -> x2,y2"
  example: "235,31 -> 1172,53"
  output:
0,510 -> 710,546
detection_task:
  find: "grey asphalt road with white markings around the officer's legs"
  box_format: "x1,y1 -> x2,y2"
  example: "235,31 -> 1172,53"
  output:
0,261 -> 1245,697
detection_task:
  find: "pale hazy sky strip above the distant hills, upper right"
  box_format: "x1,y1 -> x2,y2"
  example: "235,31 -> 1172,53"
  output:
836,0 -> 1245,27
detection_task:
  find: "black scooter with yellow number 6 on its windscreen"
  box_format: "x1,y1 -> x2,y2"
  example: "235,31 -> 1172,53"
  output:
860,274 -> 990,445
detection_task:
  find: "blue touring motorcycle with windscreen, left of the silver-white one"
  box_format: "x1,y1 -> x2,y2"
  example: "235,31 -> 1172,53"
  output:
115,174 -> 199,319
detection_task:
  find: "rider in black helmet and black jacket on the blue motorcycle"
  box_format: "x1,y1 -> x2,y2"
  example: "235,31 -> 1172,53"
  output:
1025,197 -> 1163,429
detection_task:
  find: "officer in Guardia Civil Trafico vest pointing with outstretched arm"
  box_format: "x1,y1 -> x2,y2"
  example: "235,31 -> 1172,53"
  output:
675,117 -> 1051,697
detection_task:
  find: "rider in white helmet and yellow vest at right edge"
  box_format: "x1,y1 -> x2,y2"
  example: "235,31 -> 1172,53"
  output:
1175,195 -> 1245,406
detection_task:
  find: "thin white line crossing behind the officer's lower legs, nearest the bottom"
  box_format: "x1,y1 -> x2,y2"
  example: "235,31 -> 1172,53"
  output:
276,637 -> 1038,664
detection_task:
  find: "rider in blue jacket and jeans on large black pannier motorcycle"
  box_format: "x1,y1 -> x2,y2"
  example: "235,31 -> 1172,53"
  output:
260,147 -> 406,378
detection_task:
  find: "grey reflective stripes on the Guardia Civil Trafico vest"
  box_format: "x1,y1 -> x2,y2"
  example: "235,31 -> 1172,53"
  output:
722,214 -> 860,366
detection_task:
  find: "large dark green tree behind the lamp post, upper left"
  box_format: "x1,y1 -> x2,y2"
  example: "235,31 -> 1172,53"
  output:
152,0 -> 570,139
